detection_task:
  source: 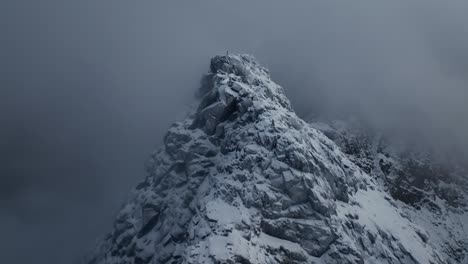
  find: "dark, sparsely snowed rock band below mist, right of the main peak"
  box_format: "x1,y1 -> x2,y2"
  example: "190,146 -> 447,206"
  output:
312,121 -> 468,207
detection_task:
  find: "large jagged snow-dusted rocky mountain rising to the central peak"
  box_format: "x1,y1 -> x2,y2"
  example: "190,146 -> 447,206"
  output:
89,55 -> 468,264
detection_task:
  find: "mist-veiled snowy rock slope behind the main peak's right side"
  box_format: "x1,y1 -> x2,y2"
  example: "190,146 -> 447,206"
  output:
311,120 -> 468,263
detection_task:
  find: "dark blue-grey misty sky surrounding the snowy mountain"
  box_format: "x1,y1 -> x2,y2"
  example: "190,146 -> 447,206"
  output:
0,0 -> 468,264
